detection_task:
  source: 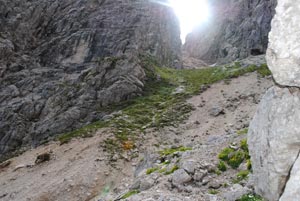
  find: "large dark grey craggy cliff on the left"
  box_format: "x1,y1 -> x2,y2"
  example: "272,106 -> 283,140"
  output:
0,0 -> 181,159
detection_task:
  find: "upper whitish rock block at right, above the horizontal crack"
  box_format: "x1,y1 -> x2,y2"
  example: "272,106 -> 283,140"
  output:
267,0 -> 300,87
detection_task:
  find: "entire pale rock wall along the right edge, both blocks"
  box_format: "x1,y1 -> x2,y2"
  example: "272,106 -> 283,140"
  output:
248,0 -> 300,201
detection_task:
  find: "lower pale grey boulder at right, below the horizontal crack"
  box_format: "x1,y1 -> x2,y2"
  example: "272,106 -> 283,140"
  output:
248,87 -> 300,201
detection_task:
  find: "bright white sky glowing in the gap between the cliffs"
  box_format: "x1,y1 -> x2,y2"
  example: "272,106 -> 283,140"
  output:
169,0 -> 209,43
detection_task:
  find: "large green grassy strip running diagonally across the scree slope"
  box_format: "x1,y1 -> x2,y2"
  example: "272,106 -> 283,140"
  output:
57,57 -> 270,152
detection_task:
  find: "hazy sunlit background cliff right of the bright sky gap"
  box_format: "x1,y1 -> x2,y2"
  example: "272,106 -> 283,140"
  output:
183,0 -> 277,64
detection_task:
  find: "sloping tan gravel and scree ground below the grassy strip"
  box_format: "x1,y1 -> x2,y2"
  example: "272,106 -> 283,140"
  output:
0,64 -> 273,201
